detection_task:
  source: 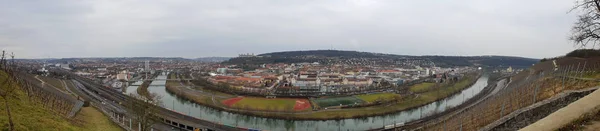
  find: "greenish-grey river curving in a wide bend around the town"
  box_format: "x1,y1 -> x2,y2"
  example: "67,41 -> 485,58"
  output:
138,74 -> 488,131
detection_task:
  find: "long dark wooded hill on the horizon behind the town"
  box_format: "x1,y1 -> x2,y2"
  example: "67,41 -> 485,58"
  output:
223,50 -> 539,67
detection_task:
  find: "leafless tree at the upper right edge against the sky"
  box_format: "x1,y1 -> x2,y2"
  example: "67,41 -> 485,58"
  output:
569,0 -> 600,47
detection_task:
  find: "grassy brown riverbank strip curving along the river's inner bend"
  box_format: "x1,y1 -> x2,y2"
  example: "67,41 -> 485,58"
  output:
166,74 -> 480,120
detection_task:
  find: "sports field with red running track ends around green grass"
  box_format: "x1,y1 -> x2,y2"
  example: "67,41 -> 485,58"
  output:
221,97 -> 310,111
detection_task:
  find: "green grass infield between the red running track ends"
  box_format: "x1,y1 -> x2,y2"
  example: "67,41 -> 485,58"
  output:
232,97 -> 296,111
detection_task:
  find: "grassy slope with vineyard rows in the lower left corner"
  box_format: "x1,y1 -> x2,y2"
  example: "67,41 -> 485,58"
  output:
0,72 -> 121,131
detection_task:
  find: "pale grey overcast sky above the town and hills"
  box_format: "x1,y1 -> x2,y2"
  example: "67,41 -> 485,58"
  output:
0,0 -> 577,58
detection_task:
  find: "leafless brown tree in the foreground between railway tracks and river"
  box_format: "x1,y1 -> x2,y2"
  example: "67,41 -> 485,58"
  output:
126,93 -> 162,131
